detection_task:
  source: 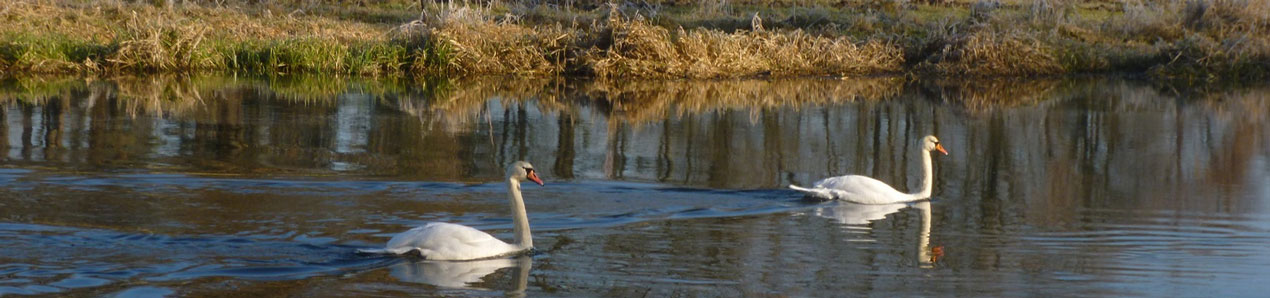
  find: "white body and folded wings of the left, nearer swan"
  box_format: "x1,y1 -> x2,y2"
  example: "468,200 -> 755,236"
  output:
373,222 -> 516,260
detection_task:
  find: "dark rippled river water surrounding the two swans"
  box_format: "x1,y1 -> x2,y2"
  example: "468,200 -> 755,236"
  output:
0,77 -> 1270,297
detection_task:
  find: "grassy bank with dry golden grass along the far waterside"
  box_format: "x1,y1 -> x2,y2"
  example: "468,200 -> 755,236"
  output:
0,0 -> 1270,81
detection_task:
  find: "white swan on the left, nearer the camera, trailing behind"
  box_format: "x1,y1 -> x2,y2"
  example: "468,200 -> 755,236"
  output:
362,161 -> 544,261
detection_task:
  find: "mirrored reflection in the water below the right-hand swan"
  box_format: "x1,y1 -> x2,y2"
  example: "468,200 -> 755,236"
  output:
814,200 -> 944,268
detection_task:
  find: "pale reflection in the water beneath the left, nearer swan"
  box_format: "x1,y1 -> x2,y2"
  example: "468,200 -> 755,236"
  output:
390,256 -> 532,291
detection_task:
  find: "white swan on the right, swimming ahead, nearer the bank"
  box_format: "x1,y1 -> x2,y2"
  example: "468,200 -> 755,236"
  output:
790,136 -> 949,204
